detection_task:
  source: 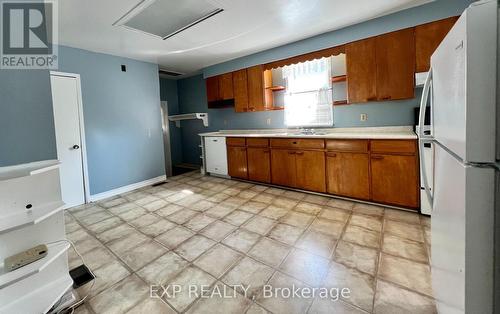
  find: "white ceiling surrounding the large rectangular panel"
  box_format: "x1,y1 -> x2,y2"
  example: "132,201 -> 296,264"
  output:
58,0 -> 430,73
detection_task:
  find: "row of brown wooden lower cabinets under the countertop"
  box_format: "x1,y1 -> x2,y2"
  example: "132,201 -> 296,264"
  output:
226,137 -> 420,209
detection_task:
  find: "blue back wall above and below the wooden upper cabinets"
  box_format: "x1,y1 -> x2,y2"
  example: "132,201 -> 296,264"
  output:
177,0 -> 474,164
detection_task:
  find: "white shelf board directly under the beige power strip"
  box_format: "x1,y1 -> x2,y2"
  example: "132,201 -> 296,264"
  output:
0,242 -> 69,289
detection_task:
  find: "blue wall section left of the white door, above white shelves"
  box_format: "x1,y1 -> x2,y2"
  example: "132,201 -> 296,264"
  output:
0,70 -> 56,167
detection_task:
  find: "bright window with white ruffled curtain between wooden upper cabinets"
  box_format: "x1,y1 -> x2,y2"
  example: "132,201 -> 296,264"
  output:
283,58 -> 333,127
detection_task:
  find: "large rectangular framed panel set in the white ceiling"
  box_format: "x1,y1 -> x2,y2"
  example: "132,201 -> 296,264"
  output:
113,0 -> 224,40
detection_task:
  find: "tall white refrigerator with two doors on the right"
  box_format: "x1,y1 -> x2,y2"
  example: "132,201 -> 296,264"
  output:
419,0 -> 500,314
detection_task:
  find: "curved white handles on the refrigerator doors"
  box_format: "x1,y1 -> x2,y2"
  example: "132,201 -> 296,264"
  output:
418,68 -> 434,208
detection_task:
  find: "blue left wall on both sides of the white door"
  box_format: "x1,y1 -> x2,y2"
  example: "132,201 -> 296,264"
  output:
0,46 -> 165,194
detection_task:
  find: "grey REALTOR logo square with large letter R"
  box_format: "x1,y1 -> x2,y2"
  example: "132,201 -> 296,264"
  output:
0,0 -> 58,69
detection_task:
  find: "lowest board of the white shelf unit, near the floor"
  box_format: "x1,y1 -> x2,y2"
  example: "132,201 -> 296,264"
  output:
0,274 -> 73,314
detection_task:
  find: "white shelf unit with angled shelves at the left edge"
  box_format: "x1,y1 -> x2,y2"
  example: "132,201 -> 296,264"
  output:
0,160 -> 73,314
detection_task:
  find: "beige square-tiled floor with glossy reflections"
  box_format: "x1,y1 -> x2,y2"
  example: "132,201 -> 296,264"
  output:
66,172 -> 436,314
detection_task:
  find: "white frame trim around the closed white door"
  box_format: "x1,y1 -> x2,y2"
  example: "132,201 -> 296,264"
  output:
50,71 -> 90,204
